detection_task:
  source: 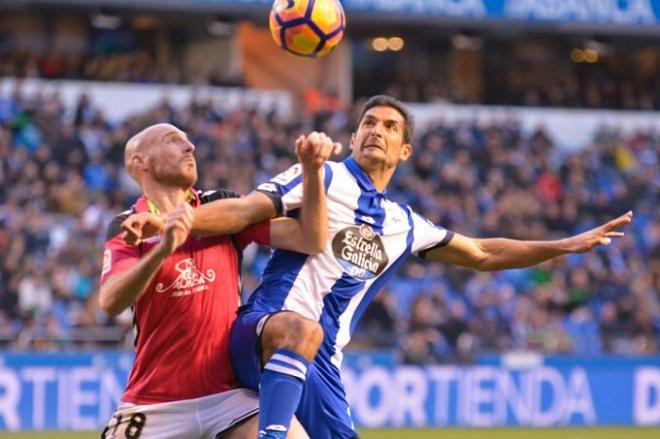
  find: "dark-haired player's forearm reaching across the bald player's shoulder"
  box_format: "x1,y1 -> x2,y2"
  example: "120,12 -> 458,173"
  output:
192,192 -> 277,236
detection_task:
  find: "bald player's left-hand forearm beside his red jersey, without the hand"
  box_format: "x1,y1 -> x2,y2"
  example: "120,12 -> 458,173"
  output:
99,245 -> 167,316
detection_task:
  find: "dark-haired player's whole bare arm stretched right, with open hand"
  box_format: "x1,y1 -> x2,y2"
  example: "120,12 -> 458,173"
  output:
426,212 -> 633,271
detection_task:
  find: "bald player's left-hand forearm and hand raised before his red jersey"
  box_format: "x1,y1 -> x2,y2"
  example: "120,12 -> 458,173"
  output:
99,204 -> 193,316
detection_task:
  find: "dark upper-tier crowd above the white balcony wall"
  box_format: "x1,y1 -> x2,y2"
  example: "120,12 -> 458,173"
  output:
0,47 -> 660,110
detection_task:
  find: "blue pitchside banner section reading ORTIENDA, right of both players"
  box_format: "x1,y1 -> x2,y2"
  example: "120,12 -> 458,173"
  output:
342,355 -> 660,428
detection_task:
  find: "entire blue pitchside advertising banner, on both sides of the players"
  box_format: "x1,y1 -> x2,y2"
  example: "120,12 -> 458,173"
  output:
0,352 -> 660,431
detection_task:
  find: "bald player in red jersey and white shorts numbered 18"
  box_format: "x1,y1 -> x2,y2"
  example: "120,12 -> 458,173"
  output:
99,124 -> 336,439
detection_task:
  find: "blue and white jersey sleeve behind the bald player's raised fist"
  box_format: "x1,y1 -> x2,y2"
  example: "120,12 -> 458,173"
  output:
257,162 -> 333,216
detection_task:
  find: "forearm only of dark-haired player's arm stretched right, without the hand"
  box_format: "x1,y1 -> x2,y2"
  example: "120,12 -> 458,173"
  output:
474,238 -> 569,271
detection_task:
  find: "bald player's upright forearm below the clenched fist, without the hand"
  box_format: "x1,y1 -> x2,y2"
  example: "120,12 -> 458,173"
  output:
299,167 -> 328,253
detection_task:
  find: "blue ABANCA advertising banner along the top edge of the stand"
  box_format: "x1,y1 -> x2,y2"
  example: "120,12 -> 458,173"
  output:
197,0 -> 660,26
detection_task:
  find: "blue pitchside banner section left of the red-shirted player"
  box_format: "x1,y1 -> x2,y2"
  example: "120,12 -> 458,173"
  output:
0,352 -> 133,431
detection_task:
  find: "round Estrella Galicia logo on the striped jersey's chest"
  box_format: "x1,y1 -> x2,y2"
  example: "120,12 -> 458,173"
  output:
332,224 -> 389,280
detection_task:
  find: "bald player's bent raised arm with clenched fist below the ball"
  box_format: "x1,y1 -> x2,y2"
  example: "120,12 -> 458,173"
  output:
270,133 -> 341,254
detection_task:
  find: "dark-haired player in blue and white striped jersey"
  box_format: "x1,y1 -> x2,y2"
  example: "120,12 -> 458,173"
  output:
125,95 -> 632,439
